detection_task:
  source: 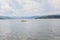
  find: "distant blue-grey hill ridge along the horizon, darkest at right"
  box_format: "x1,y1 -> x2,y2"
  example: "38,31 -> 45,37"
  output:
0,15 -> 60,19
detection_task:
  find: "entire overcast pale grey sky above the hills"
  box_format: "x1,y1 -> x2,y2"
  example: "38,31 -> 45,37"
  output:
0,0 -> 60,16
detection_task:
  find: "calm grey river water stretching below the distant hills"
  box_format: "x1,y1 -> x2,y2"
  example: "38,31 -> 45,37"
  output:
0,19 -> 60,40
